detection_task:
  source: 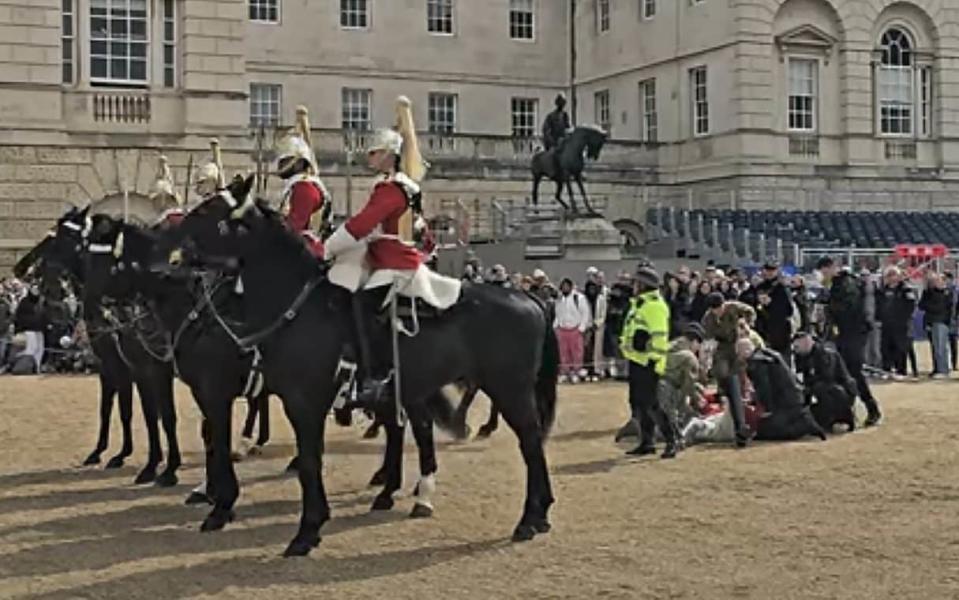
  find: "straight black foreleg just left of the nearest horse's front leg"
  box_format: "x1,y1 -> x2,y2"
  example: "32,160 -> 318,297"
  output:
200,393 -> 240,532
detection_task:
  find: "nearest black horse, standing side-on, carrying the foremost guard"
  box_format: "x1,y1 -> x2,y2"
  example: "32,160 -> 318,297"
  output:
164,186 -> 557,556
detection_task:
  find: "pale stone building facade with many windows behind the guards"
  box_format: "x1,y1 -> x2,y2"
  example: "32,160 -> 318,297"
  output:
0,0 -> 959,266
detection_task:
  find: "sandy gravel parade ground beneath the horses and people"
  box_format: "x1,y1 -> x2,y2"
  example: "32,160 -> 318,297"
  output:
0,377 -> 959,600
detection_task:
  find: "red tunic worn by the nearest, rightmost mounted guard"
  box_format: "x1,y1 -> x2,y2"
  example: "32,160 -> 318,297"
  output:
345,181 -> 423,271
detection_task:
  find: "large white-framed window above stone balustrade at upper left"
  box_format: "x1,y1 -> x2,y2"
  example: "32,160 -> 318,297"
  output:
90,0 -> 150,85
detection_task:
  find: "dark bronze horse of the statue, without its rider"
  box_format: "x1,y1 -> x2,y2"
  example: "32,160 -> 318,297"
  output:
530,125 -> 607,214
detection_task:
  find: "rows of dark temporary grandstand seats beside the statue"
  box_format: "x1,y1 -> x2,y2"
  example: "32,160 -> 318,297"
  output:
646,207 -> 959,264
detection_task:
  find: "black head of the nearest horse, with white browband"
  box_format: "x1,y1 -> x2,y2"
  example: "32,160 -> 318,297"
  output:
160,175 -> 261,266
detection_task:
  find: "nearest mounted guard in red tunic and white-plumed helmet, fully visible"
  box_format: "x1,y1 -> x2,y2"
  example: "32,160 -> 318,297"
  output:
326,96 -> 461,404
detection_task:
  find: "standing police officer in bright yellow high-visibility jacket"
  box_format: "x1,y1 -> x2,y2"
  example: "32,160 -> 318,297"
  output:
617,267 -> 679,458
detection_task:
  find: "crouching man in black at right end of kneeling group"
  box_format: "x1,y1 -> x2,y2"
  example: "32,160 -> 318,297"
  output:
793,332 -> 858,431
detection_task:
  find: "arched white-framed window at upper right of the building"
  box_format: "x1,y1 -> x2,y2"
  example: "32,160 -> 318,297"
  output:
876,27 -> 932,137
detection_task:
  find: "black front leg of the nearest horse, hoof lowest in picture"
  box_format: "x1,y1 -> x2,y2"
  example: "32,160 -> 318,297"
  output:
283,390 -> 334,556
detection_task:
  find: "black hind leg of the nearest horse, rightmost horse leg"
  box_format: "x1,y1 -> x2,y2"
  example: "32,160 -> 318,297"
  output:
484,381 -> 553,542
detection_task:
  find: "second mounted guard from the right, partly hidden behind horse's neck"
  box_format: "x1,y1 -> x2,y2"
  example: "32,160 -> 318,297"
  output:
276,106 -> 333,258
